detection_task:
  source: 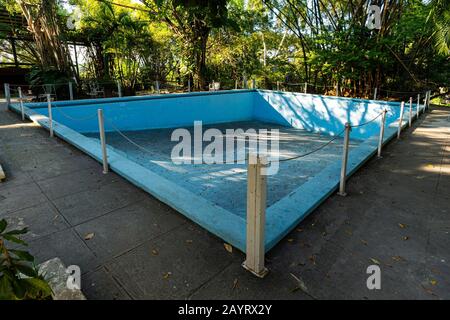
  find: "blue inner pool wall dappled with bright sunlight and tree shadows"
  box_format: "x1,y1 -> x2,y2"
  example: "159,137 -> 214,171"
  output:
253,90 -> 400,140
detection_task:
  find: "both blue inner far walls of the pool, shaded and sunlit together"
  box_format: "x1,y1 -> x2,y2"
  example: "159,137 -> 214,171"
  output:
22,90 -> 406,139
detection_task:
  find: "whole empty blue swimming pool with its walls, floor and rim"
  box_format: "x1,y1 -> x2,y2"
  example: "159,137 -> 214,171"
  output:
10,90 -> 416,251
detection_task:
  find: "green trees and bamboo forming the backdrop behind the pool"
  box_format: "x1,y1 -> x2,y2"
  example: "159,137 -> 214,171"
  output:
0,0 -> 450,97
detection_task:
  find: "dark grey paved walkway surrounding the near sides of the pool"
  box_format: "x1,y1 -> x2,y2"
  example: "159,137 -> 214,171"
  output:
0,105 -> 450,299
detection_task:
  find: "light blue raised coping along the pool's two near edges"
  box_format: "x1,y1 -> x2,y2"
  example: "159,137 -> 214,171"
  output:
9,94 -> 422,252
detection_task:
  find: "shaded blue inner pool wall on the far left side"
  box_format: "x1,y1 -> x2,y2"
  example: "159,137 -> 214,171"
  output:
31,90 -> 254,133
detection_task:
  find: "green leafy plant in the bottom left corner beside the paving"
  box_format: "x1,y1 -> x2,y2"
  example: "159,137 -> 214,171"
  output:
0,219 -> 52,300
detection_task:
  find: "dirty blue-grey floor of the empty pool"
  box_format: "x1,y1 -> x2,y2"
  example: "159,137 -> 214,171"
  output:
85,121 -> 361,217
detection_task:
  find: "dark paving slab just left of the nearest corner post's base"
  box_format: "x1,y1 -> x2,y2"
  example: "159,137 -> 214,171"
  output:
106,225 -> 242,299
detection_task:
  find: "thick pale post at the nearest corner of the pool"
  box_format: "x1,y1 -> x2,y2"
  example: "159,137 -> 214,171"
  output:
242,154 -> 268,278
